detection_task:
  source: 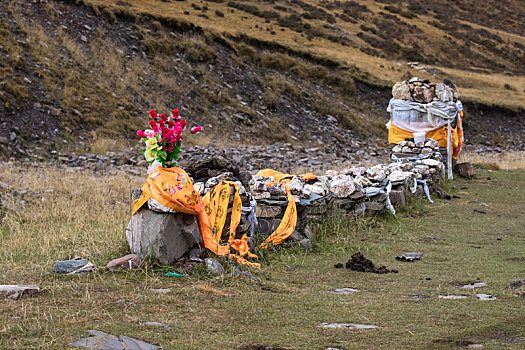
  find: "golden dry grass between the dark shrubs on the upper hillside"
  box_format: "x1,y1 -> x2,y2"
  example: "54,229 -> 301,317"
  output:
81,0 -> 525,108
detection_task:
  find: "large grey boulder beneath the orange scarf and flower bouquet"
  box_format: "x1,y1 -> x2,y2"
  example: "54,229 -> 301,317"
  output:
126,209 -> 201,265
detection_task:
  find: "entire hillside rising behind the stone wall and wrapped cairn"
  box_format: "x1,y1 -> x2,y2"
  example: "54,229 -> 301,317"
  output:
0,0 -> 525,159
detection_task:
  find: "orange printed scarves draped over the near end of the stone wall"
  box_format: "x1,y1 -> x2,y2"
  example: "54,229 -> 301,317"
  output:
132,168 -> 304,268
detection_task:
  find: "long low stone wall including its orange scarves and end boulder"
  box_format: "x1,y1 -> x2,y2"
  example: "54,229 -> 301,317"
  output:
126,151 -> 443,267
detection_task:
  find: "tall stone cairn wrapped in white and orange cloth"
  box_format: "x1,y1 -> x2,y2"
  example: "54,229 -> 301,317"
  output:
387,77 -> 463,179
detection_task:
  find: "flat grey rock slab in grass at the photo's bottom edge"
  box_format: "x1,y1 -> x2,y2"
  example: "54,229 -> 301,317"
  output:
69,330 -> 160,350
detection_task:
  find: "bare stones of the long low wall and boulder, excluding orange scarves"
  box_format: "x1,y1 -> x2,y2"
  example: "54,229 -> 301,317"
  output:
126,152 -> 443,265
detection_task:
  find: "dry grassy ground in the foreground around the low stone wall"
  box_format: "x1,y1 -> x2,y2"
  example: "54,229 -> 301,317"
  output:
0,164 -> 524,350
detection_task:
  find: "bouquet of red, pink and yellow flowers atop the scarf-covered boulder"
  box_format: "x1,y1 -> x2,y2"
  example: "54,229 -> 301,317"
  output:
137,109 -> 202,173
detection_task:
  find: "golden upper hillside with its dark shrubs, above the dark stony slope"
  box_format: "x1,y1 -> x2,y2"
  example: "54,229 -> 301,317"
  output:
88,0 -> 525,107
